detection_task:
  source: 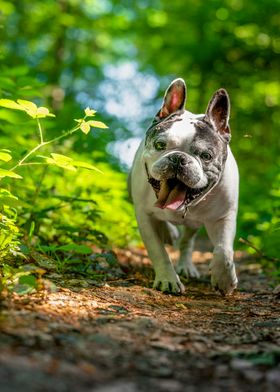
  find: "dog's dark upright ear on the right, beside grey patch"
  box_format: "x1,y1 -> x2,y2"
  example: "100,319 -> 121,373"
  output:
205,88 -> 230,141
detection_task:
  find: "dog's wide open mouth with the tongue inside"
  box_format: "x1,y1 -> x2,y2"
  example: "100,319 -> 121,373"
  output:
152,178 -> 209,210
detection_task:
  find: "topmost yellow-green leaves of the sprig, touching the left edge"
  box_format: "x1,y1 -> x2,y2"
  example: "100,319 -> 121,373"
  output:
0,99 -> 55,118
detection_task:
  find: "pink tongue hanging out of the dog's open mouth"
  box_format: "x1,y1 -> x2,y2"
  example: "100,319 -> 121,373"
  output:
155,181 -> 186,210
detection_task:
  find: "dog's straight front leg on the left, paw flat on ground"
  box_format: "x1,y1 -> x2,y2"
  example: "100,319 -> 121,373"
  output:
136,211 -> 185,294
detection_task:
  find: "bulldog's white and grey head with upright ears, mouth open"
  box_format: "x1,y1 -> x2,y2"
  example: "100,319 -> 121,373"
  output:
144,79 -> 230,210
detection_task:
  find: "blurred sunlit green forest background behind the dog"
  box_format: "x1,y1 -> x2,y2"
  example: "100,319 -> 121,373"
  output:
0,0 -> 280,288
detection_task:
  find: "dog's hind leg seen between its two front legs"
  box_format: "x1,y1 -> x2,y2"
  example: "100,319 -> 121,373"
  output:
176,226 -> 200,278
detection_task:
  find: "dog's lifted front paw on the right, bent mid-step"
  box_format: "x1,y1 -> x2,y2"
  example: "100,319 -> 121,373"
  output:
210,260 -> 238,295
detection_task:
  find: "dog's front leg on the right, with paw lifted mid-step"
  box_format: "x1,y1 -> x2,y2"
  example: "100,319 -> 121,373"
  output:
205,212 -> 238,295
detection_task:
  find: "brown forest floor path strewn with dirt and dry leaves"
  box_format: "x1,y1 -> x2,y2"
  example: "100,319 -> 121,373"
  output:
0,243 -> 280,392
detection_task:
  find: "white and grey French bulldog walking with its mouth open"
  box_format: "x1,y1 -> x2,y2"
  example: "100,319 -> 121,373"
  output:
129,78 -> 239,295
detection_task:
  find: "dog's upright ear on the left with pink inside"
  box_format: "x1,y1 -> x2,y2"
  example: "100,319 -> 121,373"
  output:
157,78 -> 187,120
